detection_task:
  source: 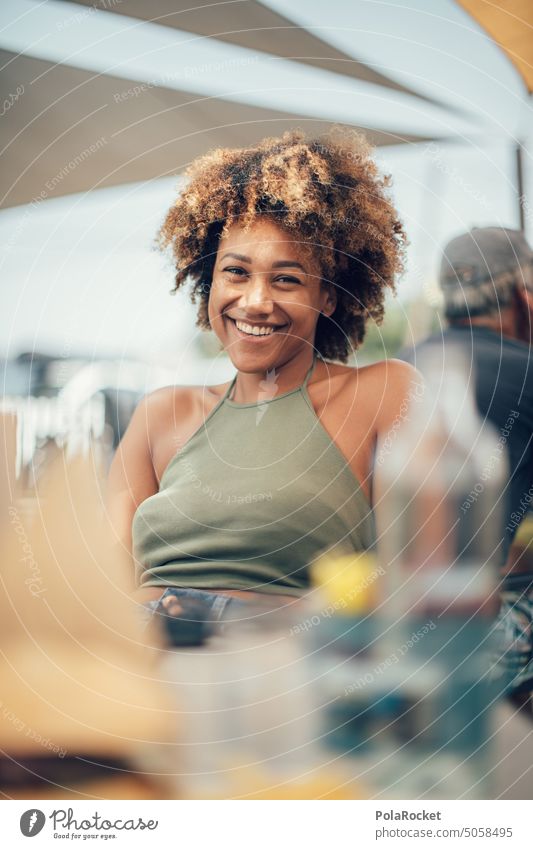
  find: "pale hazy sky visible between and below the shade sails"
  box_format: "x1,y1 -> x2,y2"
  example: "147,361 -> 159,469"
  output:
0,0 -> 533,362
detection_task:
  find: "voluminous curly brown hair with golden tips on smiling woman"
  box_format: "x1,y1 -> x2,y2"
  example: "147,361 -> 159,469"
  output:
158,127 -> 407,362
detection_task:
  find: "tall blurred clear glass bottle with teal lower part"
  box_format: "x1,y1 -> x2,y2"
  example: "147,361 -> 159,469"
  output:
375,353 -> 508,795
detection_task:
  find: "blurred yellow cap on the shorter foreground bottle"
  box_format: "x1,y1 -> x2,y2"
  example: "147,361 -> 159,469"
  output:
311,552 -> 383,615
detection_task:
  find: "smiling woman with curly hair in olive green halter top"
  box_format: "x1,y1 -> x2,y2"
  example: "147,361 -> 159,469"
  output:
106,126 -> 417,612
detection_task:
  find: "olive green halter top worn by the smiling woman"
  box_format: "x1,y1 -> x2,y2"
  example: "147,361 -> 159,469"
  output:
133,358 -> 375,595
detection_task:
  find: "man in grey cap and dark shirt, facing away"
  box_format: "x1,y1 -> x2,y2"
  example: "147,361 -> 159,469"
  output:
400,227 -> 533,710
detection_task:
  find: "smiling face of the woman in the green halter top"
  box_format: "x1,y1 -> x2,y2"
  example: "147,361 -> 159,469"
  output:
208,219 -> 335,372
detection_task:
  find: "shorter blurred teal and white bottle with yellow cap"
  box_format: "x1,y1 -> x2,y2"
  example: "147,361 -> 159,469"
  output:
307,546 -> 449,798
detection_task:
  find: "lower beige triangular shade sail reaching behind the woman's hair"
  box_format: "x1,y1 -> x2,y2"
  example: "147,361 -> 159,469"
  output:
0,51 -> 432,207
